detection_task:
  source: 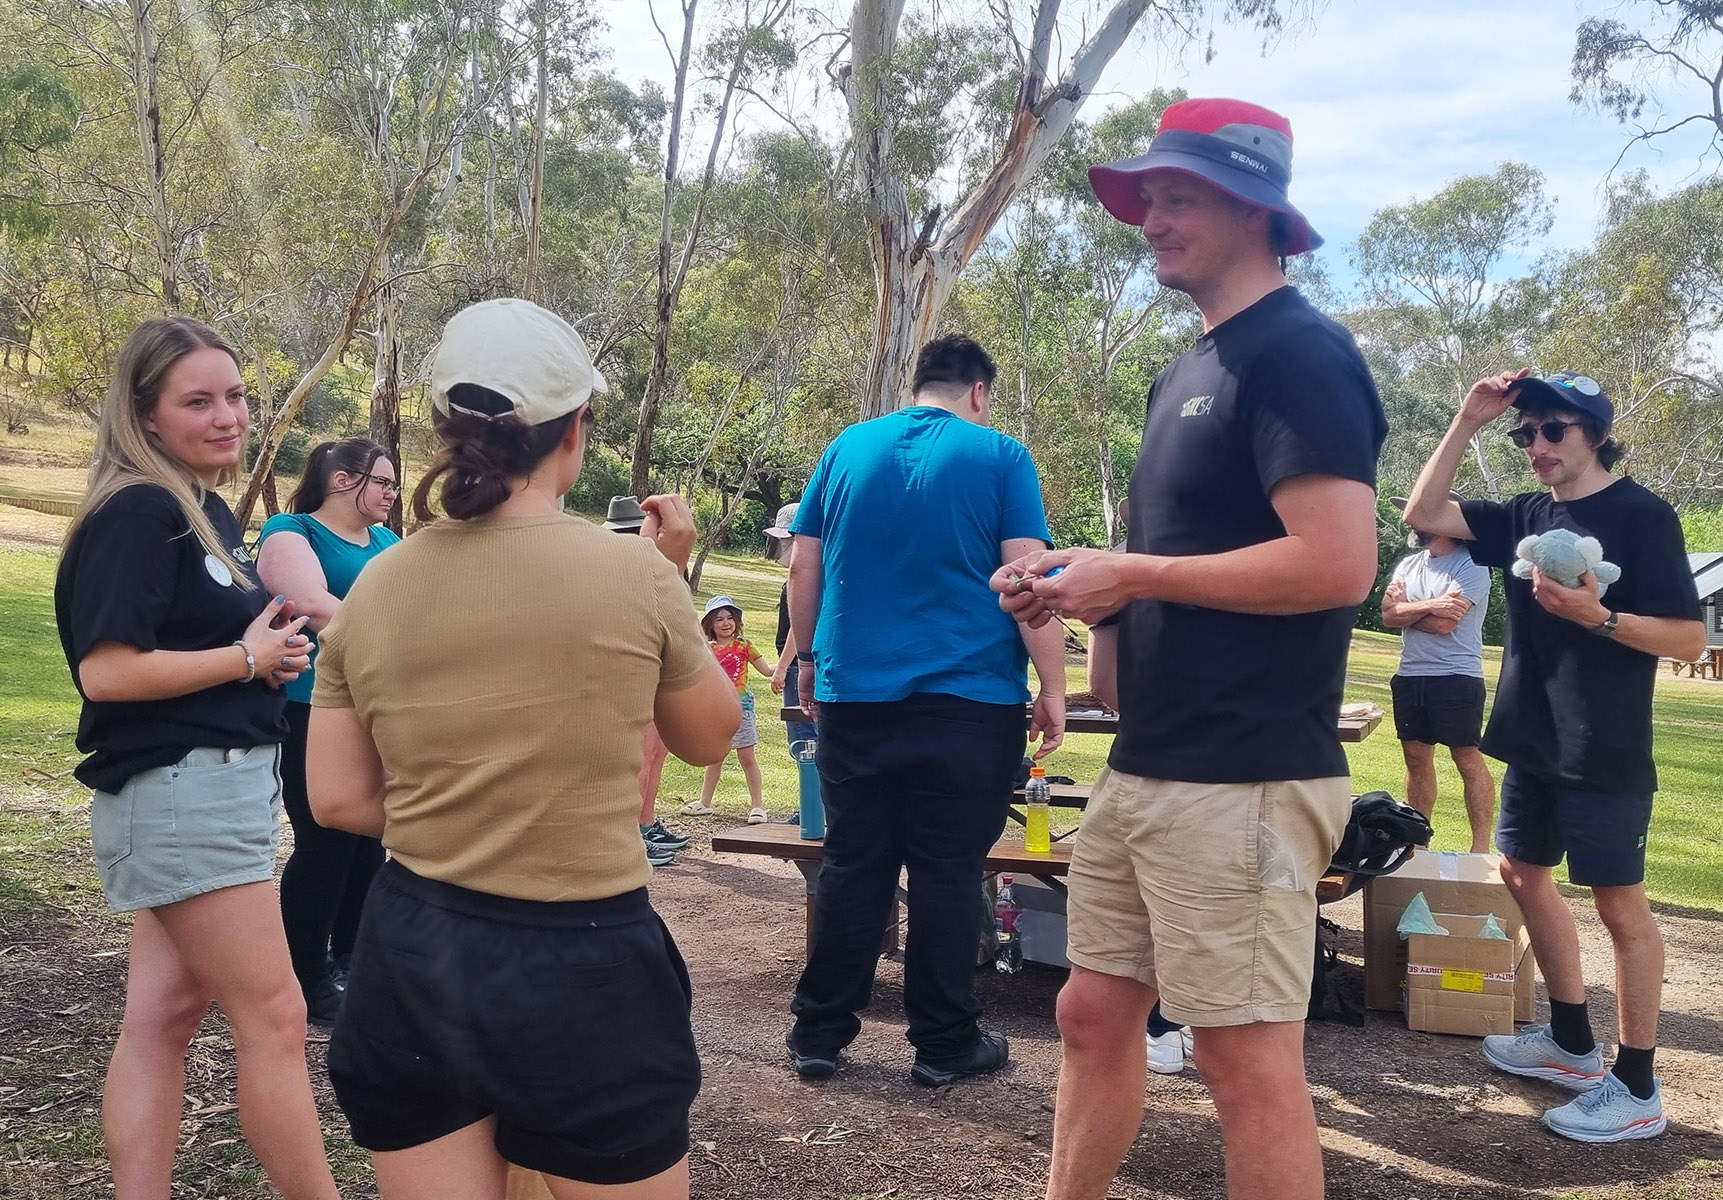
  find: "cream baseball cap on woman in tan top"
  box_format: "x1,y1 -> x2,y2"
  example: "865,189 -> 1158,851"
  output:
431,300 -> 610,426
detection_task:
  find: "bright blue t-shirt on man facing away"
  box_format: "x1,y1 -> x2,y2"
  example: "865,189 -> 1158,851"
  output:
791,405 -> 1051,703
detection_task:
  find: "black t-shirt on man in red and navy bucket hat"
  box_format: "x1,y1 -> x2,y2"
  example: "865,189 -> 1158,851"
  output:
1110,288 -> 1387,783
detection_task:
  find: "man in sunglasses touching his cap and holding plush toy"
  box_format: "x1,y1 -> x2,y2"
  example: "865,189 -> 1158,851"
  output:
1406,371 -> 1706,1141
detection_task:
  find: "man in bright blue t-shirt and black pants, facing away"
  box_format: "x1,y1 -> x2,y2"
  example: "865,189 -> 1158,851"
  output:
786,336 -> 1065,1086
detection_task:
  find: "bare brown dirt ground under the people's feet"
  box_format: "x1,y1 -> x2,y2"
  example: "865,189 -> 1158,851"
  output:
0,800 -> 1723,1200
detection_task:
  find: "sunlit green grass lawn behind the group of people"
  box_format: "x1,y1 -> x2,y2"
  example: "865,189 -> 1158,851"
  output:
0,550 -> 1723,922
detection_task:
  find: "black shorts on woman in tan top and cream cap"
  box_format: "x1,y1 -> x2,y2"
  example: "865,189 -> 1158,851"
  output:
329,862 -> 700,1184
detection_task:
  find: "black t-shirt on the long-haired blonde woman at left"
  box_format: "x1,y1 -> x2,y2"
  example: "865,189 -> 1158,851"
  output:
53,483 -> 288,791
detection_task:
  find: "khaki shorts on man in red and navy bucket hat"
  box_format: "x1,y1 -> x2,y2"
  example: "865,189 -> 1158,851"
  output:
1068,769 -> 1353,1026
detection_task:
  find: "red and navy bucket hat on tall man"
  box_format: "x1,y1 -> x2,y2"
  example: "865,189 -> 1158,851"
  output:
1089,98 -> 1322,255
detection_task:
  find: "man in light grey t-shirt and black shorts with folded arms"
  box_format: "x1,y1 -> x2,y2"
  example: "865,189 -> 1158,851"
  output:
1382,497 -> 1496,853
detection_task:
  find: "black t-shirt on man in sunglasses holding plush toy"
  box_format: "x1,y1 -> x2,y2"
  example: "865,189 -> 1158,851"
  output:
1459,479 -> 1699,793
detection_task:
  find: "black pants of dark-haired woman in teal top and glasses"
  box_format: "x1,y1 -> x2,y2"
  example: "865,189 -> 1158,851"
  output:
281,702 -> 383,988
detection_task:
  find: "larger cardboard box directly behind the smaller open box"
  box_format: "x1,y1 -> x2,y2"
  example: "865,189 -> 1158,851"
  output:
1365,850 -> 1537,1021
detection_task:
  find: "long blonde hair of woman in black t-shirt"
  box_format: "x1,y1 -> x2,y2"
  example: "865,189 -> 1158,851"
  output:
65,317 -> 257,590
